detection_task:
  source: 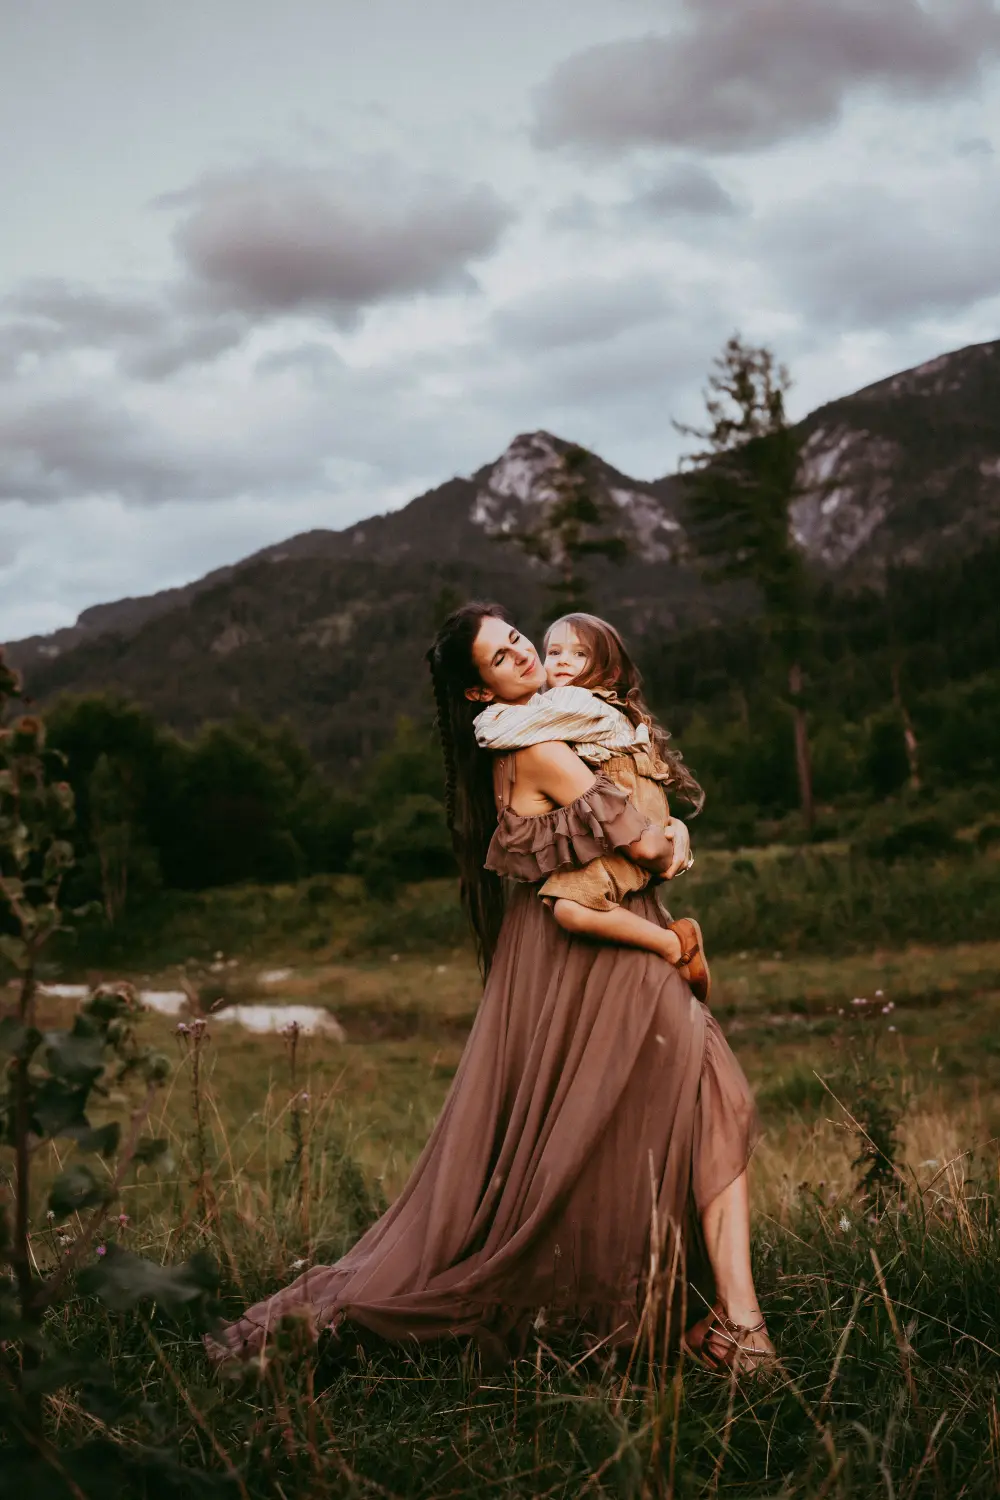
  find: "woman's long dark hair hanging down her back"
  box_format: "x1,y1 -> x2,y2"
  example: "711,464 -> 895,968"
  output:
427,600 -> 513,978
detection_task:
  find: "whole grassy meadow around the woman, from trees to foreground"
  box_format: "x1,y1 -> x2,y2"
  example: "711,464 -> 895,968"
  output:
7,849 -> 1000,1500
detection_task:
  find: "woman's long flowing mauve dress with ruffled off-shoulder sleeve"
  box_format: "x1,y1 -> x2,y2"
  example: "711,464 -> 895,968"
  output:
210,777 -> 756,1356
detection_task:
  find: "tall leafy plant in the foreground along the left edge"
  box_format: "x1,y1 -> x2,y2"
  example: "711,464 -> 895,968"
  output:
0,651 -> 220,1494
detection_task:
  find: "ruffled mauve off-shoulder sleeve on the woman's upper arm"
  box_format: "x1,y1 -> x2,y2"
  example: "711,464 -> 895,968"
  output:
486,776 -> 651,884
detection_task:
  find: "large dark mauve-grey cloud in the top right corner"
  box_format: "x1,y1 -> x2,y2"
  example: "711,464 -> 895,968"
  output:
534,0 -> 1000,153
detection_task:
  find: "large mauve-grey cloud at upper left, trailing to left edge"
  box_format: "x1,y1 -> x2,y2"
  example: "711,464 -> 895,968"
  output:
0,155 -> 511,381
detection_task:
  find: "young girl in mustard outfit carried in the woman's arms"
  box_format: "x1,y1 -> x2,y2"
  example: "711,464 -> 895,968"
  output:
475,614 -> 711,1001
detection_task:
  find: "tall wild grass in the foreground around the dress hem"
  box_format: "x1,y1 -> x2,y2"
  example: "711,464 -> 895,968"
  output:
13,978 -> 1000,1500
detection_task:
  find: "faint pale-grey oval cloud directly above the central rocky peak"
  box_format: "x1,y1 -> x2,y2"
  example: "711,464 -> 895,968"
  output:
492,275 -> 670,353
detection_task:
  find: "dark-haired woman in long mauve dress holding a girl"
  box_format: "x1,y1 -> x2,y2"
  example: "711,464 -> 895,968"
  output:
212,605 -> 772,1368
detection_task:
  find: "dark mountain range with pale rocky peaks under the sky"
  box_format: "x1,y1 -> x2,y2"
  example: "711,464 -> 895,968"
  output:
7,341 -> 1000,767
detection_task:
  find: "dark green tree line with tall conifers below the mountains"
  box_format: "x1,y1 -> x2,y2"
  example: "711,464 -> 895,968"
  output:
13,338 -> 1000,924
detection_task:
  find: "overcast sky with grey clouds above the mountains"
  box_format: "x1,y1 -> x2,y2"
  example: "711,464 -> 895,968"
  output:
0,0 -> 1000,639
